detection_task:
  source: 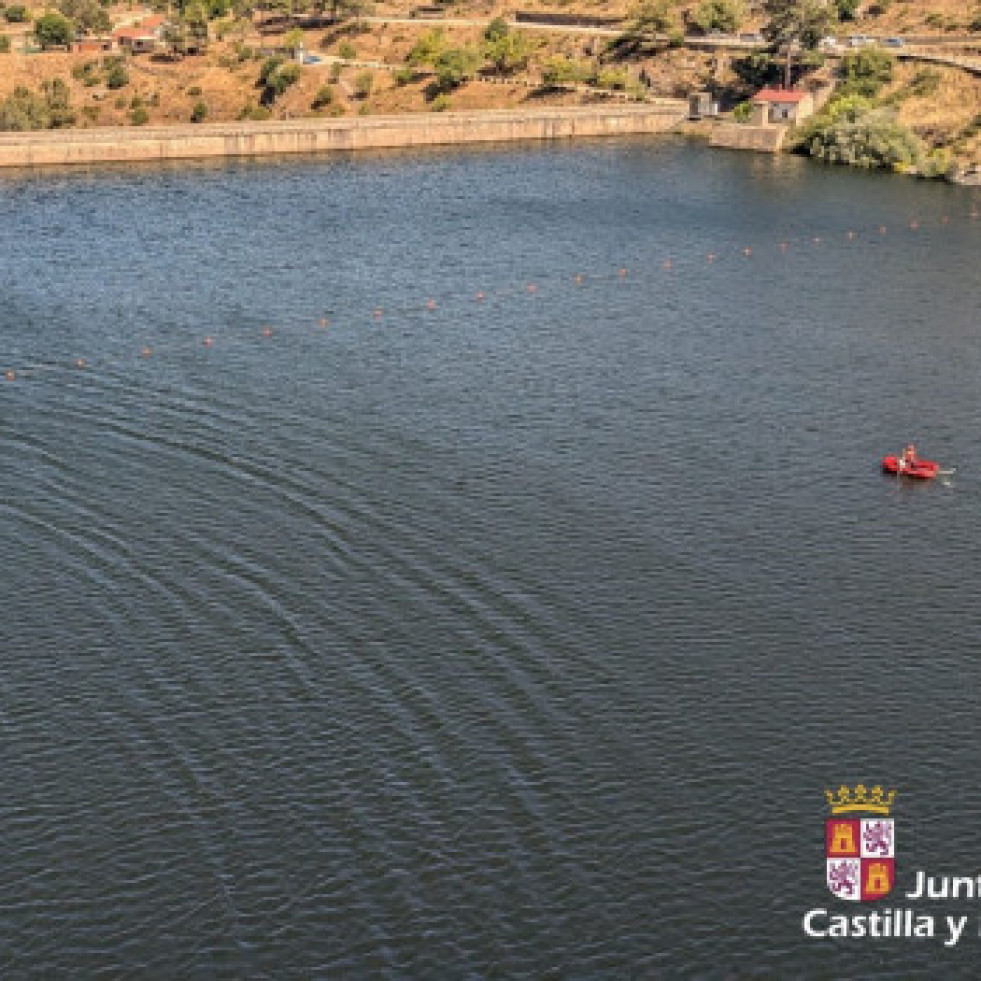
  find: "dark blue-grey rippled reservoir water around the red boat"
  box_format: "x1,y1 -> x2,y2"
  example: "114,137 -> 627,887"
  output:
0,140 -> 981,979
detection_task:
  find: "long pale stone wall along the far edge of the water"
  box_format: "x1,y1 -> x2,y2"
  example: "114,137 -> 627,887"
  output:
0,106 -> 687,167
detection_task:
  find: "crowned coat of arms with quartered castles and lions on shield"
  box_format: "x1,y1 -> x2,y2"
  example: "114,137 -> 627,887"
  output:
824,784 -> 896,902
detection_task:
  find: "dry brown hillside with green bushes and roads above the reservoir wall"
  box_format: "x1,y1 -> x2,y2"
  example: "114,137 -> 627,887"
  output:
0,0 -> 981,181
